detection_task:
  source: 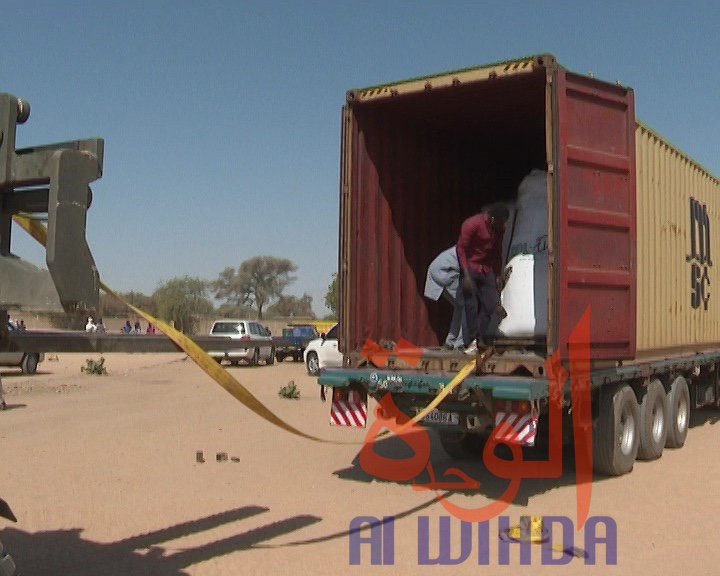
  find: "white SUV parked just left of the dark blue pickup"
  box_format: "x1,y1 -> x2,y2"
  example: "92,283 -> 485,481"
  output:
208,319 -> 275,366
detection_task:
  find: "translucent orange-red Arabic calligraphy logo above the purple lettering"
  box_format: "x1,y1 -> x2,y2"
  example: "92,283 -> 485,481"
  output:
360,307 -> 593,530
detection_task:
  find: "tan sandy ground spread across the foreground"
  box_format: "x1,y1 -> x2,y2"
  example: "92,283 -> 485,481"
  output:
0,354 -> 720,576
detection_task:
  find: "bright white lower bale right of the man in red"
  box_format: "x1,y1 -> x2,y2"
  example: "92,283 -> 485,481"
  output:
498,252 -> 548,338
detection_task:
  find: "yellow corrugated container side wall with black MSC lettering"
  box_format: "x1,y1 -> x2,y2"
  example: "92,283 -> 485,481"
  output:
635,123 -> 720,357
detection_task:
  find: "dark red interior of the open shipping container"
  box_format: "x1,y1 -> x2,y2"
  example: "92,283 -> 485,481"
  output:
341,69 -> 547,352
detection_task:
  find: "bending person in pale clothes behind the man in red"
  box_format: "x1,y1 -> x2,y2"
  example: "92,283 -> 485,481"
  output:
425,246 -> 467,350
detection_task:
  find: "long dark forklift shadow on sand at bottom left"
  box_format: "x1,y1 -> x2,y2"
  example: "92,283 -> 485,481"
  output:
0,506 -> 322,576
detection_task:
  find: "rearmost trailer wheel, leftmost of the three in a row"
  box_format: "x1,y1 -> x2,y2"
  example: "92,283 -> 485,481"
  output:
593,383 -> 640,476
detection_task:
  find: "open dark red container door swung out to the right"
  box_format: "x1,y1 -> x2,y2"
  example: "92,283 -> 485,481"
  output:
548,68 -> 636,360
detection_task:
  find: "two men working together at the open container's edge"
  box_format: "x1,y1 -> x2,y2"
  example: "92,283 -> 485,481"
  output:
425,203 -> 510,354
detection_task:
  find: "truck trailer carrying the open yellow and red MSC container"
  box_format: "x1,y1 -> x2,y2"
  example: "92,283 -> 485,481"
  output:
319,54 -> 720,475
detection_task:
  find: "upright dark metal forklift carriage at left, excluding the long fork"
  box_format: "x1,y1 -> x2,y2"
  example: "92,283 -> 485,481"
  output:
0,93 -> 104,349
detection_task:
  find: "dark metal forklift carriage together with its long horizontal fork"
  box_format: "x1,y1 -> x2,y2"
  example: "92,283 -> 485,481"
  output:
0,93 -> 300,352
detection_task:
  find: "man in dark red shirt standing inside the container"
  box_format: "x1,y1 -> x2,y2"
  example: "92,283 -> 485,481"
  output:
457,203 -> 510,354
